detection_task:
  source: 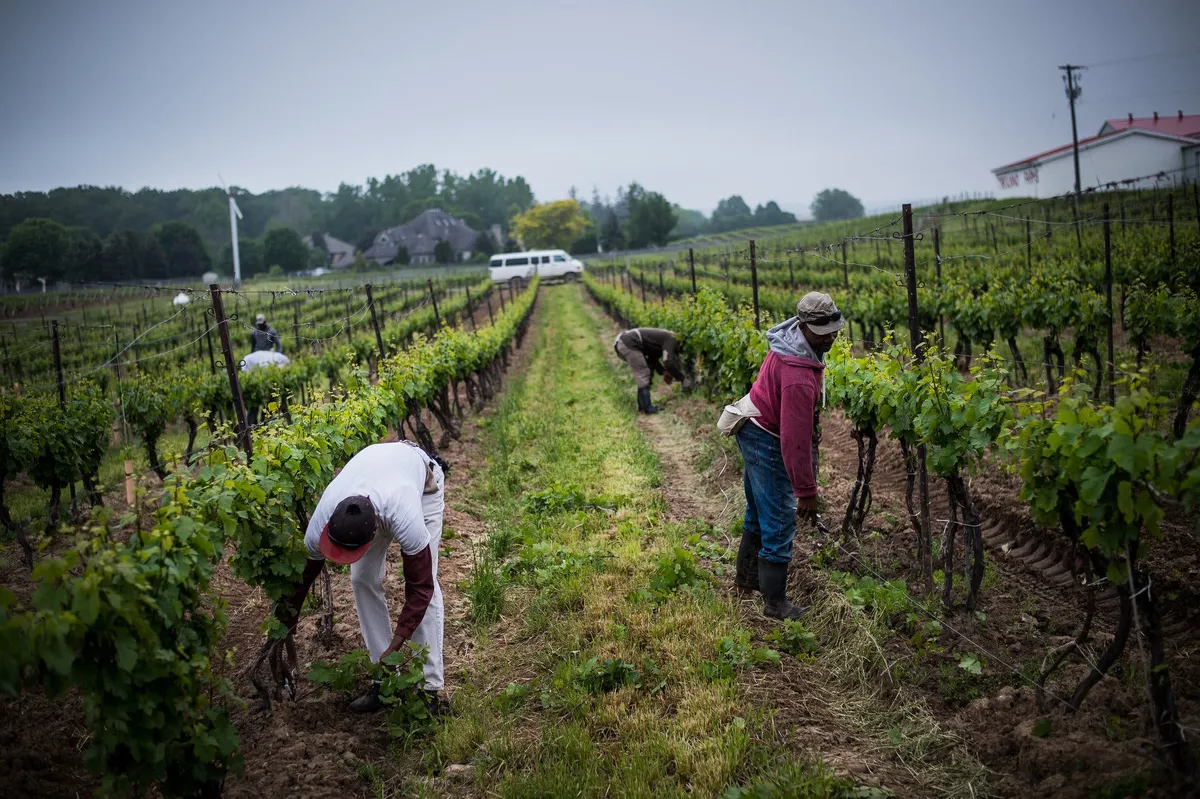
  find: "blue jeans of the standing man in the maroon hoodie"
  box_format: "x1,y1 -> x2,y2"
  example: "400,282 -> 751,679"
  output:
738,421 -> 796,563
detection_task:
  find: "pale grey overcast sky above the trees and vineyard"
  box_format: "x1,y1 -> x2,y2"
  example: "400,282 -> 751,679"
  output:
0,0 -> 1200,211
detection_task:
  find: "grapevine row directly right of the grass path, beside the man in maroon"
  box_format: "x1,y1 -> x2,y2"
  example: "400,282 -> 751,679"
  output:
586,276 -> 1200,765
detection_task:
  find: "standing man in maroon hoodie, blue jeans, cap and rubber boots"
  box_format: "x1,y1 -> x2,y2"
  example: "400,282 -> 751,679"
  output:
734,292 -> 846,619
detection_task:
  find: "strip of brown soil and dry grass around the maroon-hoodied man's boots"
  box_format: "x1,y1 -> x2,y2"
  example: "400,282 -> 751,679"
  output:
586,284 -> 989,797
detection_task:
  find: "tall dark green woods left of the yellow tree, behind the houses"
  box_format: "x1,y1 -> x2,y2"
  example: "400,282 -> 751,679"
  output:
0,164 -> 534,282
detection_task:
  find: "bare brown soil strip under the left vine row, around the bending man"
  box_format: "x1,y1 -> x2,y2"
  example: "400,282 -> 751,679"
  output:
214,287 -> 539,798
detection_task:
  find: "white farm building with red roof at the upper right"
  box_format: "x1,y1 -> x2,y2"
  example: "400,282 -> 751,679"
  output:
991,110 -> 1200,197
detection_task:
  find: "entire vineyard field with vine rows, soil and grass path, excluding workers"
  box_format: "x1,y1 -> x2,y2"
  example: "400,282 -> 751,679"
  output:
0,187 -> 1200,797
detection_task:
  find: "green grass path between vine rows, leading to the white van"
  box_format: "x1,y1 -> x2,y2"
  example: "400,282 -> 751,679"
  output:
417,287 -> 884,797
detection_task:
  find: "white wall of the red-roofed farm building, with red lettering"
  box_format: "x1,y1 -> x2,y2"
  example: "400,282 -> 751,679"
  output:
996,134 -> 1183,198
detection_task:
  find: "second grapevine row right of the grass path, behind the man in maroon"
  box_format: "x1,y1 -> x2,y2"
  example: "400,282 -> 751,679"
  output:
601,224 -> 1200,417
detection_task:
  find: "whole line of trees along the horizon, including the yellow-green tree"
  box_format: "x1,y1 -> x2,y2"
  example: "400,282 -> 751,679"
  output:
0,164 -> 863,283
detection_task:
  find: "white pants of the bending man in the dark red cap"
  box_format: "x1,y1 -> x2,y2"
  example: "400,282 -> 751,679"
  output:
350,464 -> 445,691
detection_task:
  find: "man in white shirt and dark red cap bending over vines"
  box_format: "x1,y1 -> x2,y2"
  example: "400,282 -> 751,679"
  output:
281,441 -> 445,713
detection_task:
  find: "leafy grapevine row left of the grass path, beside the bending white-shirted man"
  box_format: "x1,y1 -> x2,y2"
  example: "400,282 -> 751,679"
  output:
0,282 -> 536,795
